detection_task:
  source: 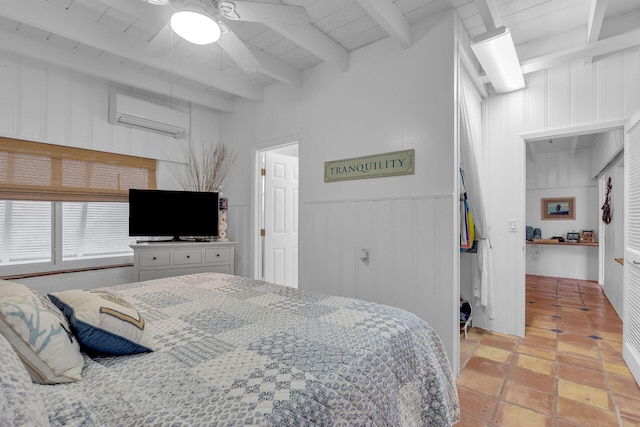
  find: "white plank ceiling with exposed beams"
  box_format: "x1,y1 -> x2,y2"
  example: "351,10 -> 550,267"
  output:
0,0 -> 640,111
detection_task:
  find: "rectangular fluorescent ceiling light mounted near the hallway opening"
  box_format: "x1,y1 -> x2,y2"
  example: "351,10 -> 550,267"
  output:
471,27 -> 524,93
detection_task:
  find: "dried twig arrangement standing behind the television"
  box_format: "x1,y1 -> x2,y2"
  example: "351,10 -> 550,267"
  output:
173,142 -> 237,191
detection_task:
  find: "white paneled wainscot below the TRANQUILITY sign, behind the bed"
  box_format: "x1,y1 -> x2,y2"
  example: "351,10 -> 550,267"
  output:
300,195 -> 459,369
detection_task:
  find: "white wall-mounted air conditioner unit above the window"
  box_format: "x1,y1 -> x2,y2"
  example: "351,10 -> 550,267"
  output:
109,93 -> 189,138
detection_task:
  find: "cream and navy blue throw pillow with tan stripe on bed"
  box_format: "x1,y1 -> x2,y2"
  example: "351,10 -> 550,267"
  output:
49,289 -> 154,355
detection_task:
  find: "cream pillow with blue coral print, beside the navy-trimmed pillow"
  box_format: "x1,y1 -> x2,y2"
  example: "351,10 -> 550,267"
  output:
0,280 -> 84,384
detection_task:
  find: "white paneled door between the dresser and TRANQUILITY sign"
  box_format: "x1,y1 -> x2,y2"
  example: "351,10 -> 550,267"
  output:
264,151 -> 298,288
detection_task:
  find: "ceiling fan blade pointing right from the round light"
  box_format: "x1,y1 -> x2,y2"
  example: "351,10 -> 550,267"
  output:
218,1 -> 311,24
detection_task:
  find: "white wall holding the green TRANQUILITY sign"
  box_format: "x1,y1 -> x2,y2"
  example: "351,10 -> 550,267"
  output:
221,12 -> 458,369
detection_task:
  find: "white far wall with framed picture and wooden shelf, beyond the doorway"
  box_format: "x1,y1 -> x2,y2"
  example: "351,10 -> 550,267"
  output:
526,148 -> 600,281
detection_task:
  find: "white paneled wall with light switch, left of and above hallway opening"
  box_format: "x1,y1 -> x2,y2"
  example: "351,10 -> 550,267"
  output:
484,47 -> 640,335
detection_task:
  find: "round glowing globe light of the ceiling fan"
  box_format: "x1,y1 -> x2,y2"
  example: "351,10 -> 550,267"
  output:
171,4 -> 220,44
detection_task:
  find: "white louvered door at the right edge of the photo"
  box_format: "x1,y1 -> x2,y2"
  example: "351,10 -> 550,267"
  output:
622,112 -> 640,382
